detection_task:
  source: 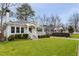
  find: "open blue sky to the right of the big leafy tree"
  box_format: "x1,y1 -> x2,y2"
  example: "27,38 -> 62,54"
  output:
30,3 -> 79,23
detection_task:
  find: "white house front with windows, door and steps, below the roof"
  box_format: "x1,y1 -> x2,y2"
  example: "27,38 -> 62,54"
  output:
4,24 -> 37,39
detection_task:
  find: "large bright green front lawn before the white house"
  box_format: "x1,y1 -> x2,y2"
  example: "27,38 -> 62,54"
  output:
0,38 -> 78,56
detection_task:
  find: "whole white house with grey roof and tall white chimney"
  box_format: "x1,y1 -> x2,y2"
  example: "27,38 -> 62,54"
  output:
0,12 -> 38,39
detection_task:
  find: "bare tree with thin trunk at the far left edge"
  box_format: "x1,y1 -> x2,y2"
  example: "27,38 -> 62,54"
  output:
0,3 -> 14,38
